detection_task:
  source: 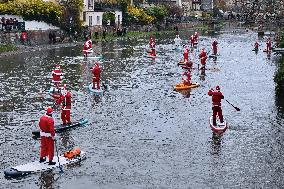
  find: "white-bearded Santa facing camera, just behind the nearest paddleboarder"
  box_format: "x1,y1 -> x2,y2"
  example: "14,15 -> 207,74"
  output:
56,84 -> 72,125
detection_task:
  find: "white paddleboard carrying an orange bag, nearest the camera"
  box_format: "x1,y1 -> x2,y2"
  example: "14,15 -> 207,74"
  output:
4,151 -> 86,178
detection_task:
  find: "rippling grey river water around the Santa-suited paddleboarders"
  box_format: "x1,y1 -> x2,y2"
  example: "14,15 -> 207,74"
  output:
0,31 -> 284,189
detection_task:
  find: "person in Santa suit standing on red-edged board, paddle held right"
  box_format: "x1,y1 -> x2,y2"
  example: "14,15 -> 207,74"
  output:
208,86 -> 224,126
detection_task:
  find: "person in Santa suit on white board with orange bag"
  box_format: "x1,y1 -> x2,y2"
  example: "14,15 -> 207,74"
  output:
39,107 -> 56,165
